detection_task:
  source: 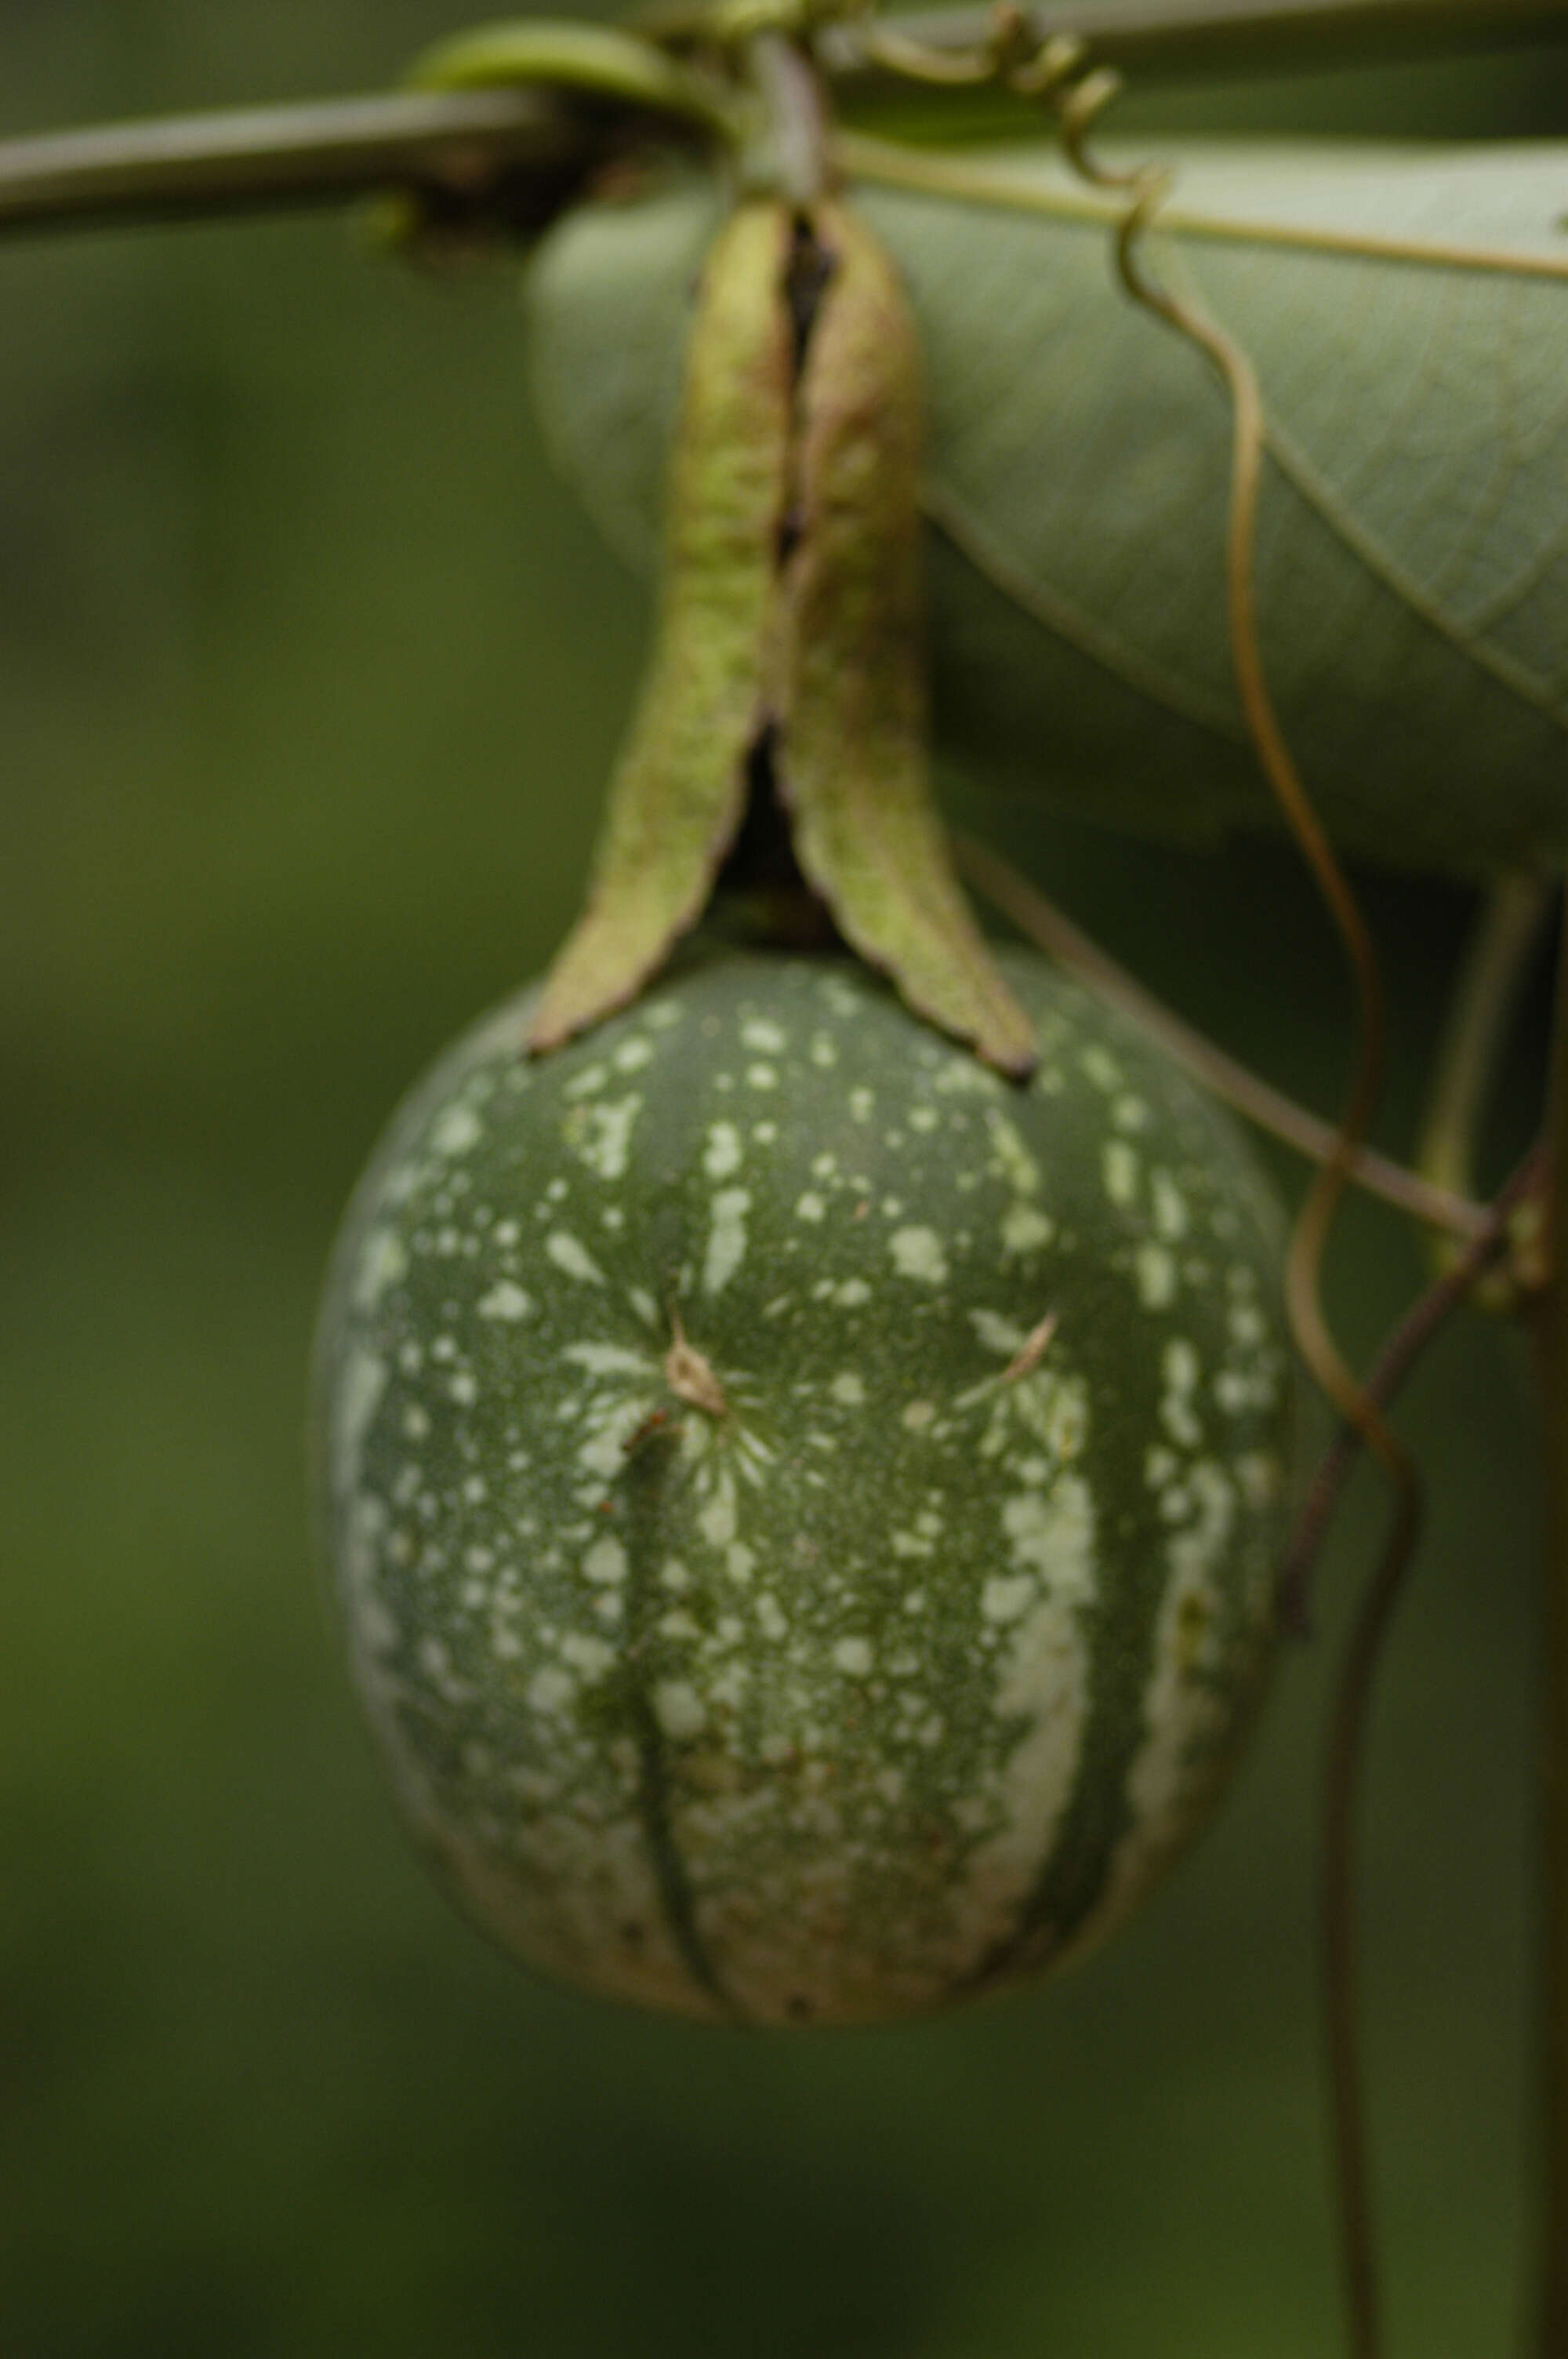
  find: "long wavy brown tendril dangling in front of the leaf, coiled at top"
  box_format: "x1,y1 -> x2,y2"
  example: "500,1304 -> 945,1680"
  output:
1058,71 -> 1422,2359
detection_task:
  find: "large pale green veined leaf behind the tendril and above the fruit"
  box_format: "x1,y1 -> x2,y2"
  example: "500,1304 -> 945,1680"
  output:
531,139 -> 1568,871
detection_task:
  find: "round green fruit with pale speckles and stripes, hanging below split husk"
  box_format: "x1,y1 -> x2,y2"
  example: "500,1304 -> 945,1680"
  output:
321,953 -> 1292,2024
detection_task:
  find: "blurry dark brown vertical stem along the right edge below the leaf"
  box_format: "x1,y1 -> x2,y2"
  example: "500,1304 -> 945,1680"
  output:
1533,887 -> 1568,2359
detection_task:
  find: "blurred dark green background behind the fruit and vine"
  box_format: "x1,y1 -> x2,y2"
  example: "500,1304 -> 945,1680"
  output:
0,0 -> 1568,2359
